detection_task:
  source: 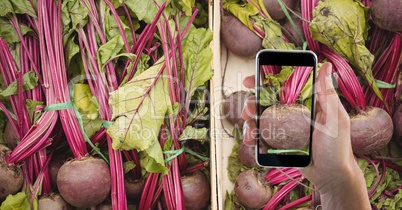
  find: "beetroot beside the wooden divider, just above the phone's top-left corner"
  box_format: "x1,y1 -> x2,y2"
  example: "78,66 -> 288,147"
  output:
221,12 -> 262,58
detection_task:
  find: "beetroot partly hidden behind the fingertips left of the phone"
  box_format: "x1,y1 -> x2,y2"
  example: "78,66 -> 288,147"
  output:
222,90 -> 251,128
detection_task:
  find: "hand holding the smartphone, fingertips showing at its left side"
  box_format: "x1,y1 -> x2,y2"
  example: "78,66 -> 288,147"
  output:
242,63 -> 369,209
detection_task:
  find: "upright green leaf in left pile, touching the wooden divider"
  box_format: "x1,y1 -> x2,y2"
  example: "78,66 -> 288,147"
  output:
183,27 -> 214,96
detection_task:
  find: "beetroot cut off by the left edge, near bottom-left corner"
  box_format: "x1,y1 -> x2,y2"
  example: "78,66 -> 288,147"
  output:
0,144 -> 24,202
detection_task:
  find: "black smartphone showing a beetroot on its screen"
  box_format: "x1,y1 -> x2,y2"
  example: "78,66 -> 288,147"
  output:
255,50 -> 317,168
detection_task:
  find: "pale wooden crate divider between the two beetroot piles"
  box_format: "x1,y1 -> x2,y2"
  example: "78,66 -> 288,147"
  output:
211,1 -> 255,209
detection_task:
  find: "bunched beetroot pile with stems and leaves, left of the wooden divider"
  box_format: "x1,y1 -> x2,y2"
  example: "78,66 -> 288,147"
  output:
0,0 -> 213,210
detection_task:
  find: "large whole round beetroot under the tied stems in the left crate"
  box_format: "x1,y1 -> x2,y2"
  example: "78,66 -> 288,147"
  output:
57,157 -> 111,208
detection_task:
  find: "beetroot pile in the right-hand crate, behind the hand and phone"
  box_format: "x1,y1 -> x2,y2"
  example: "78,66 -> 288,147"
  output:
221,0 -> 402,209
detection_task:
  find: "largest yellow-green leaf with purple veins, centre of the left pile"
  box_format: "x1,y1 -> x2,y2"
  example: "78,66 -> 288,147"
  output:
107,58 -> 172,174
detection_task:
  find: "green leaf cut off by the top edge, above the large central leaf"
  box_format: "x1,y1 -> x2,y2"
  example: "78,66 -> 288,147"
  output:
120,0 -> 165,24
